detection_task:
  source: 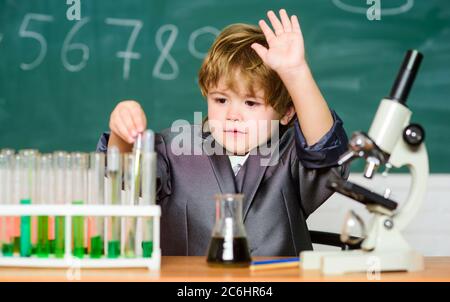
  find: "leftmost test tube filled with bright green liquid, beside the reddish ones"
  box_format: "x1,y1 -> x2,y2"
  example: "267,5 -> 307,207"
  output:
18,149 -> 38,257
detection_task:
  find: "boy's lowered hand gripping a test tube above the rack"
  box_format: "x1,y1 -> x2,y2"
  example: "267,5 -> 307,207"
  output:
109,101 -> 147,144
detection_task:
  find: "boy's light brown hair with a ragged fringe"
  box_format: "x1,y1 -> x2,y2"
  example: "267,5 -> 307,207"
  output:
198,23 -> 292,116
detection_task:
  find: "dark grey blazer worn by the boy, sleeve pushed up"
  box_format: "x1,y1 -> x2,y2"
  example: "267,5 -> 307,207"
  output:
97,111 -> 348,256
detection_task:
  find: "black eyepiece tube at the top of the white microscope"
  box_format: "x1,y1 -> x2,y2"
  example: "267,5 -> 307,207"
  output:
389,49 -> 423,104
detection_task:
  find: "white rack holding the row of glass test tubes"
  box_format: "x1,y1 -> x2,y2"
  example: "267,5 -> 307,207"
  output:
0,204 -> 161,270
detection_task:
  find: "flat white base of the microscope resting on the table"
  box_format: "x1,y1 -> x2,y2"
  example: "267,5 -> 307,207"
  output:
300,250 -> 424,275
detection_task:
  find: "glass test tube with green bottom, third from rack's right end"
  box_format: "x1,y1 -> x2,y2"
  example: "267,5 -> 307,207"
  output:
107,146 -> 122,258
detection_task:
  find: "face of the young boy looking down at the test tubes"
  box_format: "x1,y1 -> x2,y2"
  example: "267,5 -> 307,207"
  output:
207,72 -> 280,155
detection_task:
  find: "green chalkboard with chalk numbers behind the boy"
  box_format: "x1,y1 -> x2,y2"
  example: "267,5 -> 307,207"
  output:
0,0 -> 450,173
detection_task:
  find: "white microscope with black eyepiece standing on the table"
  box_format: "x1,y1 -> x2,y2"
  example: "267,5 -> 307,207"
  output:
300,50 -> 428,275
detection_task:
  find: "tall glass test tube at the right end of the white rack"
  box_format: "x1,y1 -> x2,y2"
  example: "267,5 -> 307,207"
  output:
140,130 -> 156,258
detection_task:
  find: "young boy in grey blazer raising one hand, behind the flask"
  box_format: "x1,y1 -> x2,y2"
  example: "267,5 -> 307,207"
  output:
98,10 -> 348,256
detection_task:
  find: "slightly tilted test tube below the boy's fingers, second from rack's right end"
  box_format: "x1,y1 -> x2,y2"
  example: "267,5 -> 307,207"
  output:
122,153 -> 139,258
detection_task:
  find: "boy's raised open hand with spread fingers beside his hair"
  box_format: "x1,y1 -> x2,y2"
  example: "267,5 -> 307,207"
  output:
252,9 -> 306,75
